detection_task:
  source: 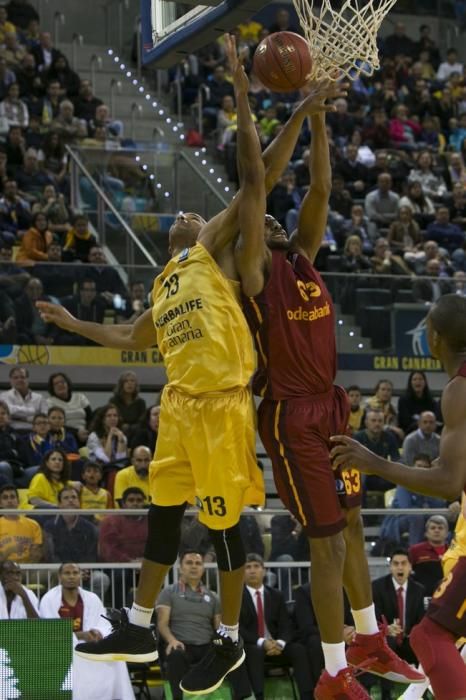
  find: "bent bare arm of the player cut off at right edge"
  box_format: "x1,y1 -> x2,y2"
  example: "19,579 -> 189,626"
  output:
331,378 -> 466,501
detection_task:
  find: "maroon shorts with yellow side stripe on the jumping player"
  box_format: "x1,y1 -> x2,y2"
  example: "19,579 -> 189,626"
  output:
259,386 -> 361,537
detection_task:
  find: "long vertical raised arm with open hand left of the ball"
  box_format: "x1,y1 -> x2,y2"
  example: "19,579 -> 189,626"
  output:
226,37 -> 268,296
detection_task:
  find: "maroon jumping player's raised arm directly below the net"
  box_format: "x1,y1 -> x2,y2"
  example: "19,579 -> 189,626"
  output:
291,102 -> 332,262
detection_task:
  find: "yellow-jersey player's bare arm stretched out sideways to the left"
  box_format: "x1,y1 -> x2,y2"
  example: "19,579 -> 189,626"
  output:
36,301 -> 156,350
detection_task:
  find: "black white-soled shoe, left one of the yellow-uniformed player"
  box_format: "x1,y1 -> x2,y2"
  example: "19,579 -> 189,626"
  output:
75,608 -> 158,663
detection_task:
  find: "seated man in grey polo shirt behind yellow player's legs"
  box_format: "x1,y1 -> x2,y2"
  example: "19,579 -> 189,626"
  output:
156,552 -> 220,700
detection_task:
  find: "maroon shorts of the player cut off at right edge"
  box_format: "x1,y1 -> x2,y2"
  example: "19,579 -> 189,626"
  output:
426,557 -> 466,639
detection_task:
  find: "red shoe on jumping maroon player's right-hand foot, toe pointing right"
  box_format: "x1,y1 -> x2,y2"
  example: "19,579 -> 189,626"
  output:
346,626 -> 426,683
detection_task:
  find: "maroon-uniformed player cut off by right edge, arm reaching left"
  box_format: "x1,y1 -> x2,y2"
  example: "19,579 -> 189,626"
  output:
332,294 -> 466,700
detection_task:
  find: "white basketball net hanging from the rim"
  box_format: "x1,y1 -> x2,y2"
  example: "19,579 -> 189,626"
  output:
293,0 -> 397,80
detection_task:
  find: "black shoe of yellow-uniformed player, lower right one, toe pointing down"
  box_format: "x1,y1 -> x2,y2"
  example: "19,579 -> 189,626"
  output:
180,634 -> 246,695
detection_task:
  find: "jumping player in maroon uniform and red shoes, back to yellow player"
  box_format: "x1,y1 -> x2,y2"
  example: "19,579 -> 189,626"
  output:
235,95 -> 424,700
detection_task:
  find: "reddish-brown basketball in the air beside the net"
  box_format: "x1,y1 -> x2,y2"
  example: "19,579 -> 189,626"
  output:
253,32 -> 312,92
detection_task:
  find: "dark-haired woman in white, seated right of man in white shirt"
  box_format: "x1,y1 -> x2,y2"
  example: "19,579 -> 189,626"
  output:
47,372 -> 92,444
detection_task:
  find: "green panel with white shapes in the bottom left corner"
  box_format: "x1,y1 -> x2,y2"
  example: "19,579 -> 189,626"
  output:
0,619 -> 73,700
